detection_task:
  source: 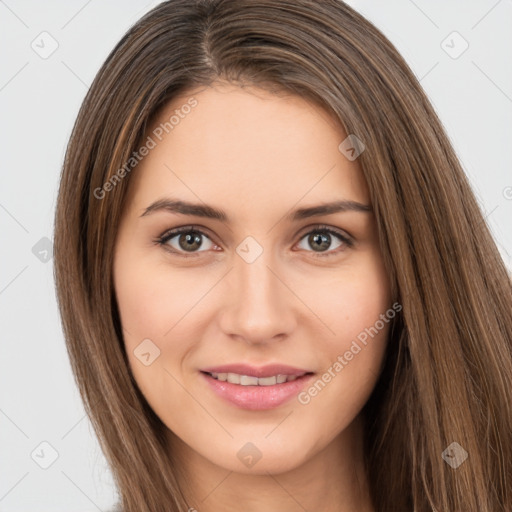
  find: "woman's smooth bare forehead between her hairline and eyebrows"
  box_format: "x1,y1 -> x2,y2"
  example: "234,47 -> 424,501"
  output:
126,84 -> 368,221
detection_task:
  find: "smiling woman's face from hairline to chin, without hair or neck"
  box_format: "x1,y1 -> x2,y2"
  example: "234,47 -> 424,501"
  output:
113,84 -> 394,474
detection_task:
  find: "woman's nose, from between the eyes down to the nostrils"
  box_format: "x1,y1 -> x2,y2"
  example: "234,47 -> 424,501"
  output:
219,246 -> 299,345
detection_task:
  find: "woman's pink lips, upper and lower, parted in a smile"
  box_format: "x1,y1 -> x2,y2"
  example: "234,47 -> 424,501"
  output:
201,365 -> 314,411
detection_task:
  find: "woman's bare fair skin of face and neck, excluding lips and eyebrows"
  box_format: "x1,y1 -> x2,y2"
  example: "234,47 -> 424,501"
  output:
114,83 -> 391,512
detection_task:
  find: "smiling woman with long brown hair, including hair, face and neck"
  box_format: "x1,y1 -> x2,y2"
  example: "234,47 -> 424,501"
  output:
54,0 -> 512,512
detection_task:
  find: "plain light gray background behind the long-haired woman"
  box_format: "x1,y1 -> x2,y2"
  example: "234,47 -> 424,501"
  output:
0,0 -> 512,512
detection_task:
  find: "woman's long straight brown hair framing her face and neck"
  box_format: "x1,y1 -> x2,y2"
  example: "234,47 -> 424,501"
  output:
54,0 -> 512,512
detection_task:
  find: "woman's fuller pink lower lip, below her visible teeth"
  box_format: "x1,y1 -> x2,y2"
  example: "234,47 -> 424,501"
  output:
201,372 -> 314,411
